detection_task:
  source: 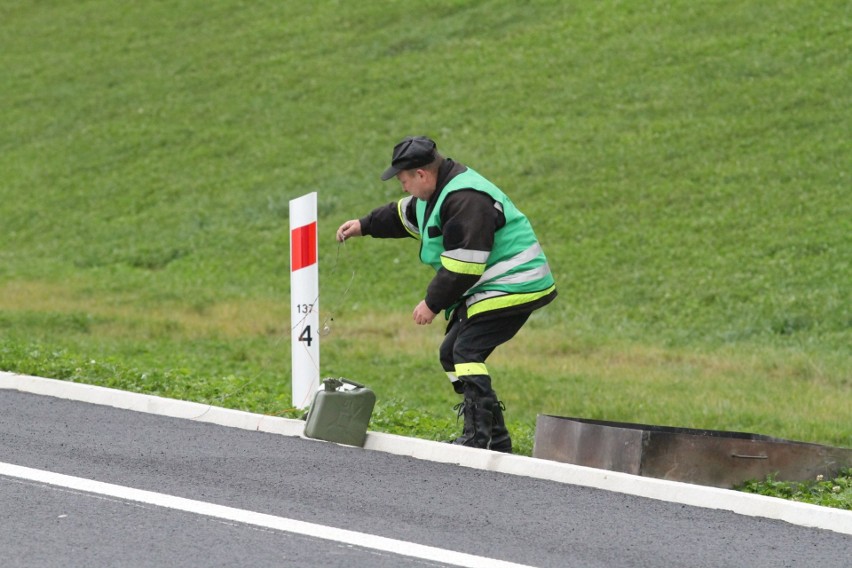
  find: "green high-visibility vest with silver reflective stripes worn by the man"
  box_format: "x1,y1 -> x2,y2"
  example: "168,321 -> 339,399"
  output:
415,168 -> 556,318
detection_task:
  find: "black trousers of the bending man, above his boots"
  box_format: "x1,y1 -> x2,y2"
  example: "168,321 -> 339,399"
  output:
440,304 -> 532,395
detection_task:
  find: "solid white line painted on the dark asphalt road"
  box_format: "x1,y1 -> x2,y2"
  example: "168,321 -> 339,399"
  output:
0,462 -> 533,568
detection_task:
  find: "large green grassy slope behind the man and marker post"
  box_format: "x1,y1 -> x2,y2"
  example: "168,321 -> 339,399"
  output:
0,0 -> 852,488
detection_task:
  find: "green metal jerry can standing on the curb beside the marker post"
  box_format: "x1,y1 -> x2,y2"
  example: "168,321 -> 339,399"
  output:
305,378 -> 376,447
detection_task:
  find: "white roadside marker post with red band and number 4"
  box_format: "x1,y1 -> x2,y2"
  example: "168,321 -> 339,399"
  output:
290,192 -> 320,408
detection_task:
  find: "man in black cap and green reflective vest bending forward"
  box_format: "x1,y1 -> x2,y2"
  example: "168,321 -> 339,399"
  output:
337,136 -> 556,453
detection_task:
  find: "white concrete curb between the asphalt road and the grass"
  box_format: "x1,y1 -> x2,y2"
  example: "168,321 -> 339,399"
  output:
0,371 -> 852,535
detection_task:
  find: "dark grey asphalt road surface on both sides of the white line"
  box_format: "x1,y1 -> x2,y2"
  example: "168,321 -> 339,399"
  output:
0,389 -> 852,568
